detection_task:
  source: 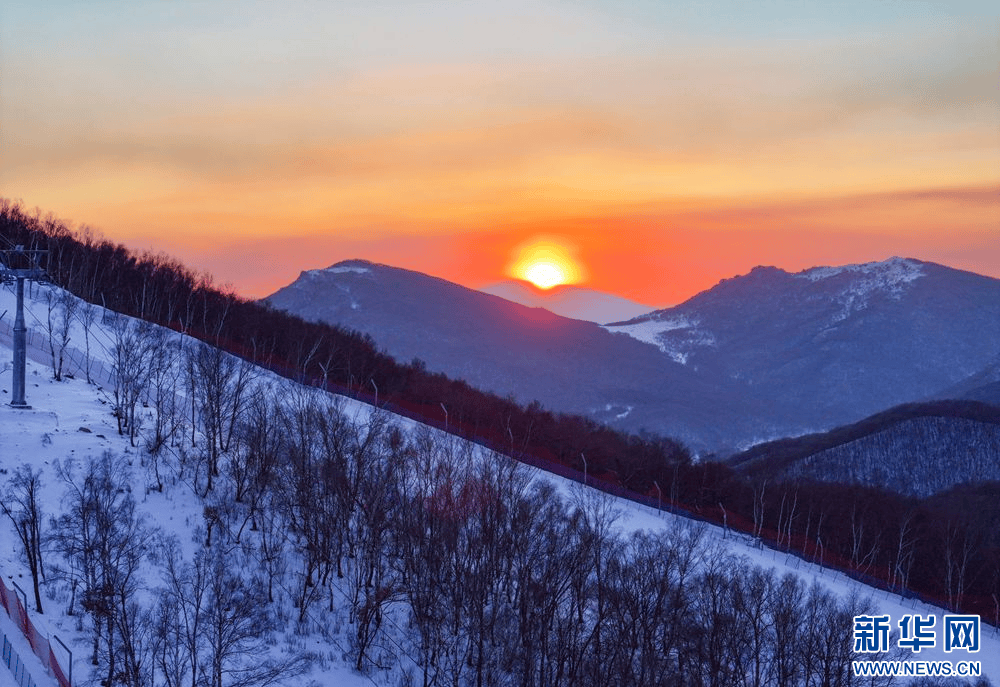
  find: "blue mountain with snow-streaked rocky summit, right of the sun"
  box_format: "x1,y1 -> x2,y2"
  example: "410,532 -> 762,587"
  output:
606,258 -> 1000,444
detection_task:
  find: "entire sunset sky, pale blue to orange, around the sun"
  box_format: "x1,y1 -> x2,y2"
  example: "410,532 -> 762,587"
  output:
0,0 -> 1000,305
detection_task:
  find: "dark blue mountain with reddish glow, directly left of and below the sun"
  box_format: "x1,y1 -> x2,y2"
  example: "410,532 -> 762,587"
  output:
266,260 -> 748,452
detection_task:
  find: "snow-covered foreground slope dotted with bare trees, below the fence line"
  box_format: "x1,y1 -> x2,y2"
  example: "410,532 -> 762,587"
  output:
0,282 -> 1000,687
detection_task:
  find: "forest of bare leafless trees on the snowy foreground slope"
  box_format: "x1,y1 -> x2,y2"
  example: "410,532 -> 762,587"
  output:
3,376 -> 912,687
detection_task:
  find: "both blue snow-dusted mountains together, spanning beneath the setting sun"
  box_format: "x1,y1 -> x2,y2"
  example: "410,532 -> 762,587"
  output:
266,258 -> 1000,454
